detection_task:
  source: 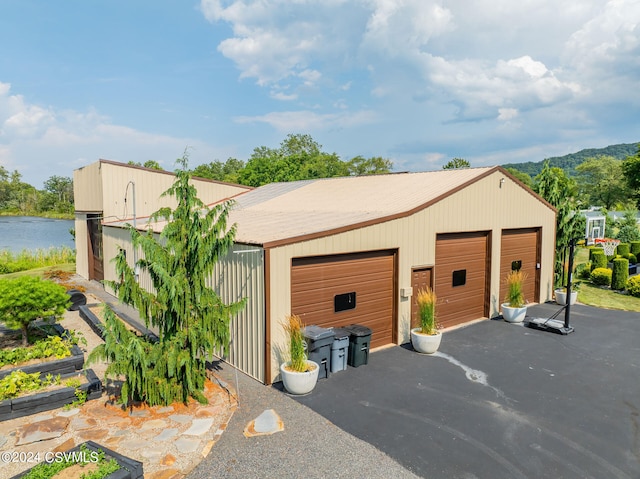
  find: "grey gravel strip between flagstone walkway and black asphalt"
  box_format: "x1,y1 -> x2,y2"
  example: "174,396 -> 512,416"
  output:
187,364 -> 418,479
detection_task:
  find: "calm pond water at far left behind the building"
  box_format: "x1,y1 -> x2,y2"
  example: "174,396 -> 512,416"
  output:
0,216 -> 76,253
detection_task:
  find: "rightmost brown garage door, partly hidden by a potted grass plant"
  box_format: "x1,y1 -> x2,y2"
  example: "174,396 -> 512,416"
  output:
500,228 -> 540,303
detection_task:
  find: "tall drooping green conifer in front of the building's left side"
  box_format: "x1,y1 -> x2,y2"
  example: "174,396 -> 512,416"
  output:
88,155 -> 244,405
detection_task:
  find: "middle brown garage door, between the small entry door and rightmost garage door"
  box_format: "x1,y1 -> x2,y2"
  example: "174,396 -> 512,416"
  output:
434,232 -> 490,327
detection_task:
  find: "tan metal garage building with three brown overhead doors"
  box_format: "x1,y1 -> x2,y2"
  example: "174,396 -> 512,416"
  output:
76,163 -> 555,384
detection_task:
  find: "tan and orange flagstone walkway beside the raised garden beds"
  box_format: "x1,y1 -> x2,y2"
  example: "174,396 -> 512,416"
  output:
0,376 -> 236,479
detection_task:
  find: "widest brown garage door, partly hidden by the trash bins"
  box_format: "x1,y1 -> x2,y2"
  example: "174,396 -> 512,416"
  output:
291,251 -> 395,348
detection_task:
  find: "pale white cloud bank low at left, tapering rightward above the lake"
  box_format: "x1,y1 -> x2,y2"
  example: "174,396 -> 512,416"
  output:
0,83 -> 234,188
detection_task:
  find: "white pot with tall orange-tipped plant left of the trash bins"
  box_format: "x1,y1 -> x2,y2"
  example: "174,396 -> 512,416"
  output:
280,314 -> 320,395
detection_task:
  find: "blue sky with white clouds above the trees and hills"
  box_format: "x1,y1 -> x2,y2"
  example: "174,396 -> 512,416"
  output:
0,0 -> 640,188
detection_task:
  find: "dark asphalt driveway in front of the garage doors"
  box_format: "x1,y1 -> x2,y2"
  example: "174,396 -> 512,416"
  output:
296,304 -> 640,479
